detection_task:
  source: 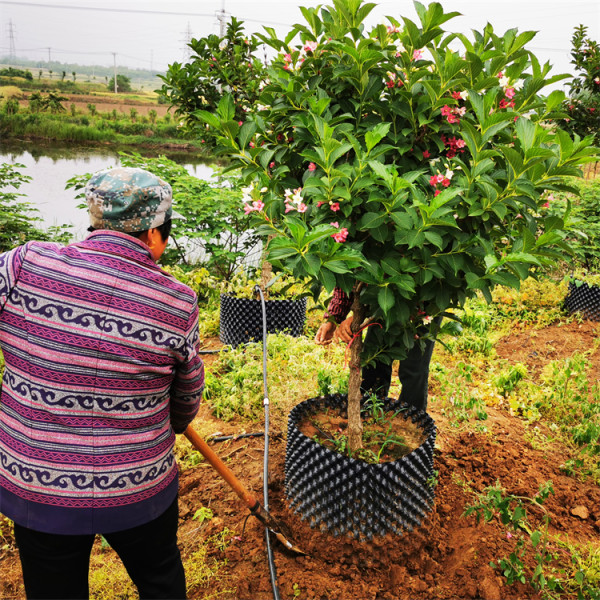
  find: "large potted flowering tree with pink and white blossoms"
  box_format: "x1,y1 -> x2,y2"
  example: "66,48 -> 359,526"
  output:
177,0 -> 597,537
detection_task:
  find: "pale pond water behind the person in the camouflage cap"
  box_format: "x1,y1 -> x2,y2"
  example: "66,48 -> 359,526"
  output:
0,142 -> 219,239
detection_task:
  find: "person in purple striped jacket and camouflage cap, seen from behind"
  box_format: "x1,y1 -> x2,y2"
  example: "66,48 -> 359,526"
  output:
0,168 -> 204,599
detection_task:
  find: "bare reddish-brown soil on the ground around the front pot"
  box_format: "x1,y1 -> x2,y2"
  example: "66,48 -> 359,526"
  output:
0,322 -> 600,600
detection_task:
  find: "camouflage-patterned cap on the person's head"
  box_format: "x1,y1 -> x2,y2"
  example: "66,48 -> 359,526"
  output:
85,167 -> 179,233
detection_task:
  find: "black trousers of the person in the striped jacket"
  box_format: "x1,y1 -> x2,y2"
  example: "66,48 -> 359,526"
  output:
15,499 -> 186,600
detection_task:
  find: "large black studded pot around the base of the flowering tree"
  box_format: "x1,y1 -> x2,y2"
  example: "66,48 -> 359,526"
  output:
285,394 -> 437,540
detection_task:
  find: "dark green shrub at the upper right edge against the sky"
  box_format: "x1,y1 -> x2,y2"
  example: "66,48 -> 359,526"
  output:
560,25 -> 600,143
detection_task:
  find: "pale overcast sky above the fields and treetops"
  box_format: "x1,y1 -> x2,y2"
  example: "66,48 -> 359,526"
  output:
0,0 -> 600,82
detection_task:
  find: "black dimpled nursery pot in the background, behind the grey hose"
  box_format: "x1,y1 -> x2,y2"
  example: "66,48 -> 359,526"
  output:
219,294 -> 306,348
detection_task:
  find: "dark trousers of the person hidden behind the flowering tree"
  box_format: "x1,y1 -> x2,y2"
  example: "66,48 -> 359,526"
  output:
360,333 -> 435,410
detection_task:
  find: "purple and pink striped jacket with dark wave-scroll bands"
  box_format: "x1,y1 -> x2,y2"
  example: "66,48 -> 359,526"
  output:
0,231 -> 204,534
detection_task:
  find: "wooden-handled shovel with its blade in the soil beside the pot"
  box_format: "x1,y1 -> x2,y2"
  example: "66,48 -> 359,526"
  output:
183,425 -> 305,554
